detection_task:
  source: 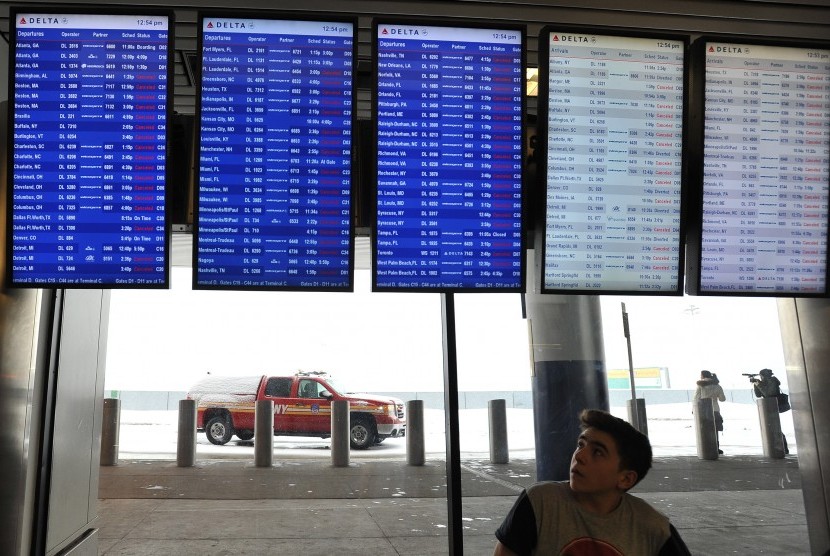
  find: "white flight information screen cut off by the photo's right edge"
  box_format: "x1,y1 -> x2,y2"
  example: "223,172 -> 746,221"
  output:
697,41 -> 830,295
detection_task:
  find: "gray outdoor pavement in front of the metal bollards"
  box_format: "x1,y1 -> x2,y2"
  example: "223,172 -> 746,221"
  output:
97,455 -> 810,556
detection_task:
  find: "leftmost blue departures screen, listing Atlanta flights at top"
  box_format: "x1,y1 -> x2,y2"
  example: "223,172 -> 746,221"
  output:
7,11 -> 172,288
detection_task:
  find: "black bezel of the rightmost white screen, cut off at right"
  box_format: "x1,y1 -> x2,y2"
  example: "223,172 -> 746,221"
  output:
686,33 -> 830,298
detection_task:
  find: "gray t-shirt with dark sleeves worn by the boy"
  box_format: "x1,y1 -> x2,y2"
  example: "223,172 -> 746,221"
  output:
496,482 -> 685,556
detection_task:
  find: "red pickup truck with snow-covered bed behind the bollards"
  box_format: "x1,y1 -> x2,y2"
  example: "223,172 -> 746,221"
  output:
187,372 -> 406,450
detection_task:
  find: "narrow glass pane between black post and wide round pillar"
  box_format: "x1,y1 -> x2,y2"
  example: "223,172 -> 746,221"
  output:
455,294 -> 536,554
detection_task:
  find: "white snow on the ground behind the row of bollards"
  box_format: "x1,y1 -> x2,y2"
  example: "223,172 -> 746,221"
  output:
119,402 -> 796,460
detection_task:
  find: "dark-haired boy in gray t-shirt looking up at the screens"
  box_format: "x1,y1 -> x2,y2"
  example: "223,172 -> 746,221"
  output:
494,409 -> 689,556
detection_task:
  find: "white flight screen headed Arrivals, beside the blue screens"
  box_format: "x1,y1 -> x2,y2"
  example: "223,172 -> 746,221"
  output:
539,28 -> 687,295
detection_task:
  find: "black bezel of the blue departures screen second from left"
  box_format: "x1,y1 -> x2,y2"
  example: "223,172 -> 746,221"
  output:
191,10 -> 359,292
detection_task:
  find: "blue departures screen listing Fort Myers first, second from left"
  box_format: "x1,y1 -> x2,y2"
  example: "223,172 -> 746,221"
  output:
193,16 -> 355,291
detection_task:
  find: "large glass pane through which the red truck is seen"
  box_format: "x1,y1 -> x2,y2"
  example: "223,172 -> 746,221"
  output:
105,267 -> 458,555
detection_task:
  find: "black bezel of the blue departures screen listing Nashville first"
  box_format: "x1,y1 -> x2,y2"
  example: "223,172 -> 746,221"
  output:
371,17 -> 528,293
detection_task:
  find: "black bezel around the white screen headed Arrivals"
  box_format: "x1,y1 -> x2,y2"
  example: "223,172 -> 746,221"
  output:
534,25 -> 690,297
